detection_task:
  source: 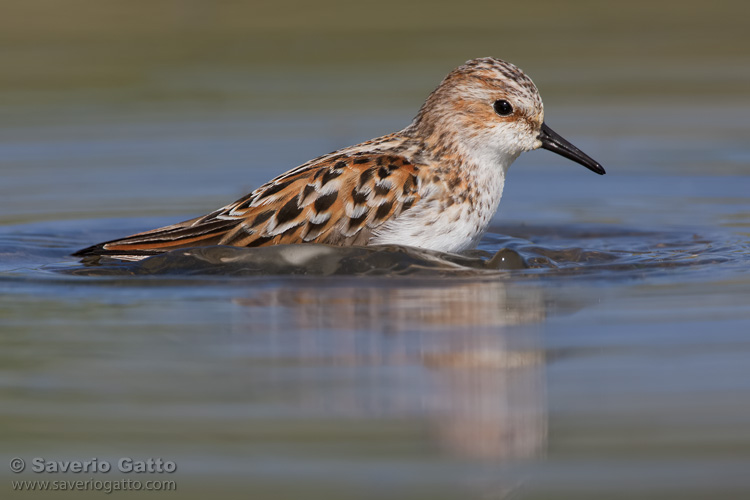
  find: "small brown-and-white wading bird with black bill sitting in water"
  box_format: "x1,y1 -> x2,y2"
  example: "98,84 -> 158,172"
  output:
74,57 -> 604,260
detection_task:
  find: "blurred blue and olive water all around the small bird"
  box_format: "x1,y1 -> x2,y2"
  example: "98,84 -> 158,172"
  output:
0,0 -> 750,499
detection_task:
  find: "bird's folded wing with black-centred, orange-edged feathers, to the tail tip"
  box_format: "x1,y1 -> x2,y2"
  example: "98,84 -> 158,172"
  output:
74,152 -> 420,259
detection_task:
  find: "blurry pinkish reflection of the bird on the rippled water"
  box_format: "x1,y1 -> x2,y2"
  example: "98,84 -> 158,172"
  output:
233,280 -> 546,458
